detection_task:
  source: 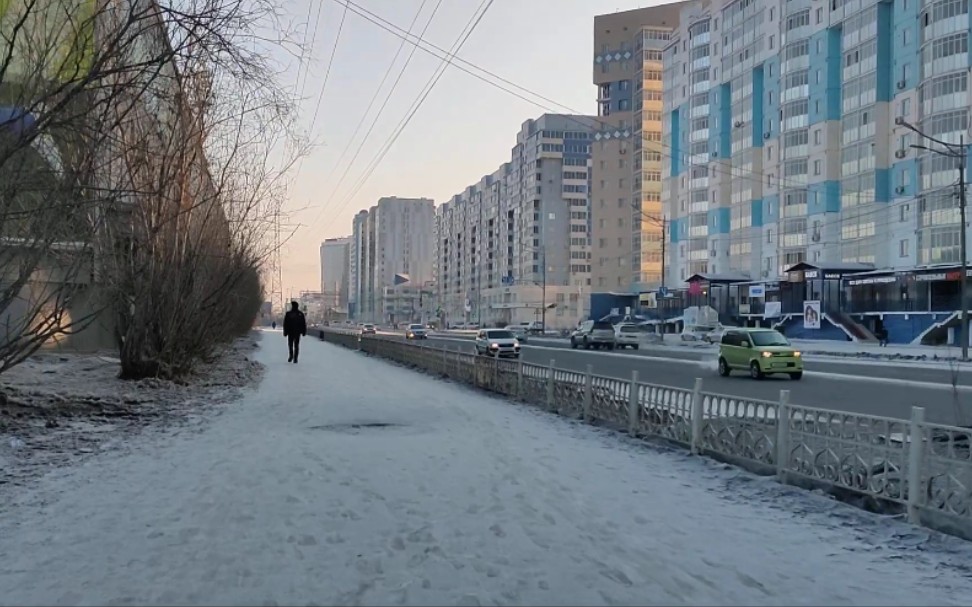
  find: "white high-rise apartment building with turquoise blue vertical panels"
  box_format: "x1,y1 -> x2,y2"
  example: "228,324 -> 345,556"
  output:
663,0 -> 972,284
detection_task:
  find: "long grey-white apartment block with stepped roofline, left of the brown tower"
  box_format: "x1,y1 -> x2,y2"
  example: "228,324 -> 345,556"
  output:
435,114 -> 596,328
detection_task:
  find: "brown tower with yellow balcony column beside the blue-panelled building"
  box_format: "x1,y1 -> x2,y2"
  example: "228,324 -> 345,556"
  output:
591,2 -> 688,292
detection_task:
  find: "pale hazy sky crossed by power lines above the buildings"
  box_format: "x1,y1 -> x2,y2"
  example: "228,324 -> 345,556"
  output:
281,0 -> 663,297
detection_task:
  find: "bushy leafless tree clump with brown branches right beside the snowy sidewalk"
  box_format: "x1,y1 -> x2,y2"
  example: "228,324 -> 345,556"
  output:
96,0 -> 294,378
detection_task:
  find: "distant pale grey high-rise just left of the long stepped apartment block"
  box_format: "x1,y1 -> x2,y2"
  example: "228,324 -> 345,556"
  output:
348,197 -> 435,322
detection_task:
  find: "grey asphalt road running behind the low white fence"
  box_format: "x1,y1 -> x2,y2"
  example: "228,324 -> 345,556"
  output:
380,335 -> 972,425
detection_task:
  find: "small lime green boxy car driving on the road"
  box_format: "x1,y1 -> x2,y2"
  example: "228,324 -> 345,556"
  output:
719,329 -> 803,379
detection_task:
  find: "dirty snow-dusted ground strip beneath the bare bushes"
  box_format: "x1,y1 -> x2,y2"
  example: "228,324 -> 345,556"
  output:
0,337 -> 262,492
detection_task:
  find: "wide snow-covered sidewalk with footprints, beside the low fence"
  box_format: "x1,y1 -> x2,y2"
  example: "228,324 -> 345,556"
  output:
0,336 -> 972,605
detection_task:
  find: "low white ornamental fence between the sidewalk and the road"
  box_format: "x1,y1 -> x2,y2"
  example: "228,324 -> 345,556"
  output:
320,330 -> 972,539
